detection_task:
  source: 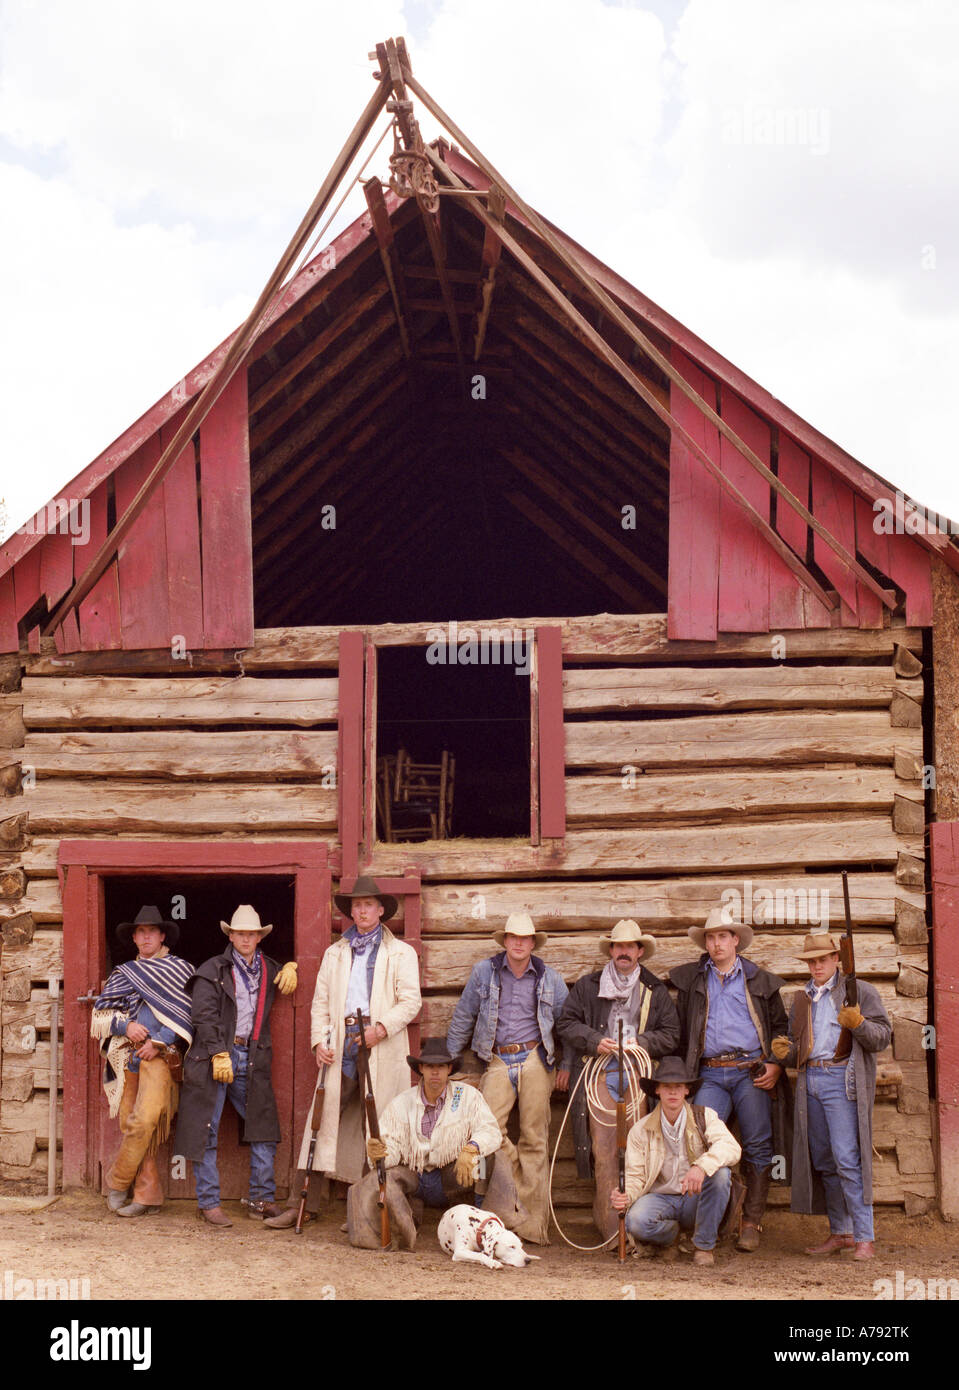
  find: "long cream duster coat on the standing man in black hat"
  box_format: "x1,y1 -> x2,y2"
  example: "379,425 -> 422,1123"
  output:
297,927 -> 423,1183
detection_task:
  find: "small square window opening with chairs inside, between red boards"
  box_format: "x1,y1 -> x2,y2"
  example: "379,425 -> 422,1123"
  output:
377,632 -> 532,841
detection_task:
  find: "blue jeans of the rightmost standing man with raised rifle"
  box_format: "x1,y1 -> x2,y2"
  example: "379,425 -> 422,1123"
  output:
806,1066 -> 873,1240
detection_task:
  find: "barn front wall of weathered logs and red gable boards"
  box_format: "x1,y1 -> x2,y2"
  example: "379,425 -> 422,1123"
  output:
0,125 -> 959,1213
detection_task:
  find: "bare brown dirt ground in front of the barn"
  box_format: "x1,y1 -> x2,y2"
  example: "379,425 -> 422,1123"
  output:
0,1193 -> 959,1301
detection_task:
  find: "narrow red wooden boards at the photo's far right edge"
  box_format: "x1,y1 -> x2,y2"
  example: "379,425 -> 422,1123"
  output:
928,820 -> 959,1220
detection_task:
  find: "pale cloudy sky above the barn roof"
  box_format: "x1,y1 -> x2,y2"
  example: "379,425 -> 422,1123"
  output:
0,0 -> 959,530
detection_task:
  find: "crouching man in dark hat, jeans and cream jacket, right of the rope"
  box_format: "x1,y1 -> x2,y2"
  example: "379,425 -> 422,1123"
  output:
610,1056 -> 741,1265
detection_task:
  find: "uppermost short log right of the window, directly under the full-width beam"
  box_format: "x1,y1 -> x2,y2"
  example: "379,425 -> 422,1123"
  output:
563,666 -> 906,713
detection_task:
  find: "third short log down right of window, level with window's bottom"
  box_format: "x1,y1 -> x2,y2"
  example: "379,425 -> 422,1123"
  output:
566,767 -> 900,834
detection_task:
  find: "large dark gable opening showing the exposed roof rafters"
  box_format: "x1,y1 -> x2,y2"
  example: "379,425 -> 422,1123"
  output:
249,150 -> 669,627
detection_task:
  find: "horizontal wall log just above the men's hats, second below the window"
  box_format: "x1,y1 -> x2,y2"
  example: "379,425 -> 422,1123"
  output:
423,872 -> 906,939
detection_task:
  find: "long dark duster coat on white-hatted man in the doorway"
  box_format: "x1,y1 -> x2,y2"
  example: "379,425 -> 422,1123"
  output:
175,947 -> 281,1163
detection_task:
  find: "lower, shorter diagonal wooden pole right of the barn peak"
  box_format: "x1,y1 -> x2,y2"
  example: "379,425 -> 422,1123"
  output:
427,150 -> 833,612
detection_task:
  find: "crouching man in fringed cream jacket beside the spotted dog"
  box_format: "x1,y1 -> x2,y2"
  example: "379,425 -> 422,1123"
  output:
347,1038 -> 516,1250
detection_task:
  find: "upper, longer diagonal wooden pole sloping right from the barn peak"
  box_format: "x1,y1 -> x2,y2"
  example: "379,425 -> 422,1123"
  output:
404,71 -> 890,607
